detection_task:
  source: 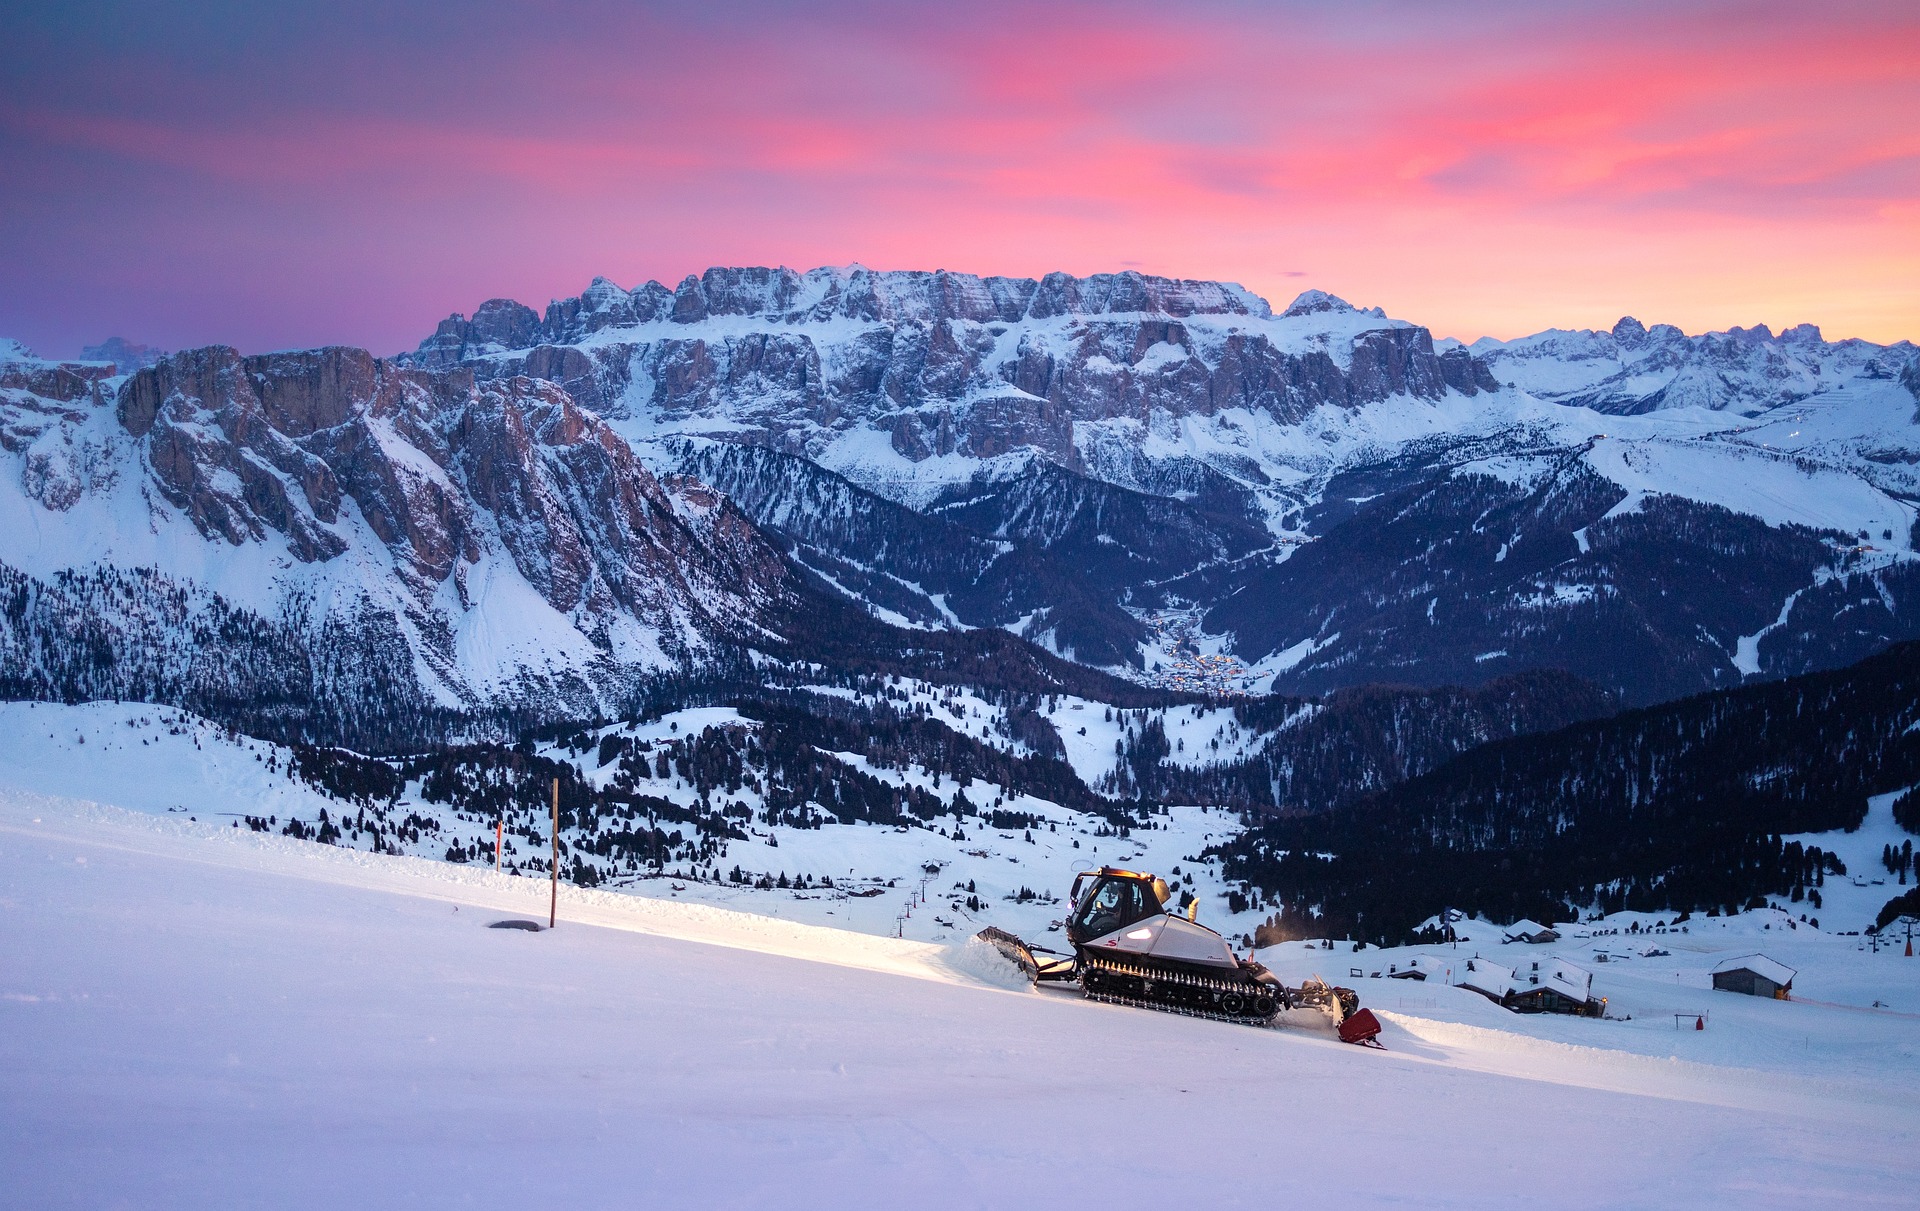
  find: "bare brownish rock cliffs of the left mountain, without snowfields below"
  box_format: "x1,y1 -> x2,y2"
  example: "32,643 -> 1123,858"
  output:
115,347 -> 778,629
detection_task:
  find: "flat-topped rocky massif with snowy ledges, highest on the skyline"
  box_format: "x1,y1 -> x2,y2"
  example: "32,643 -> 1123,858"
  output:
409,267 -> 1498,464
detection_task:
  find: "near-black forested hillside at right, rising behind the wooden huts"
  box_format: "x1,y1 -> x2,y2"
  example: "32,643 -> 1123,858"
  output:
1225,643 -> 1920,938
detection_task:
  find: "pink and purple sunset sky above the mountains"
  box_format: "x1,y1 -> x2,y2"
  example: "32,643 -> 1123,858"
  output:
0,0 -> 1920,355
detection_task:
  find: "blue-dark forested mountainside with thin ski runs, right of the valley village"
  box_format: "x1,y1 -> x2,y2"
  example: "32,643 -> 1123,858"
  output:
1183,452 -> 1873,704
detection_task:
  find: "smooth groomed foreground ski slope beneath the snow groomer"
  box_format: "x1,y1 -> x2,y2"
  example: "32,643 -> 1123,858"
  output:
0,748 -> 1920,1207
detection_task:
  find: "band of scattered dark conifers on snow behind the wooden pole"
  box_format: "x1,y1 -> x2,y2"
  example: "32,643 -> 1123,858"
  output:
280,677 -> 1154,887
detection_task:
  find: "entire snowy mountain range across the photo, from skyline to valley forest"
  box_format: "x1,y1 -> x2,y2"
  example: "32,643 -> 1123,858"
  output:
0,267 -> 1920,744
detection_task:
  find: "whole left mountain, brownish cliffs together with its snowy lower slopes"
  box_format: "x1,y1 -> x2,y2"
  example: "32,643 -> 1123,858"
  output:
0,335 -> 789,725
